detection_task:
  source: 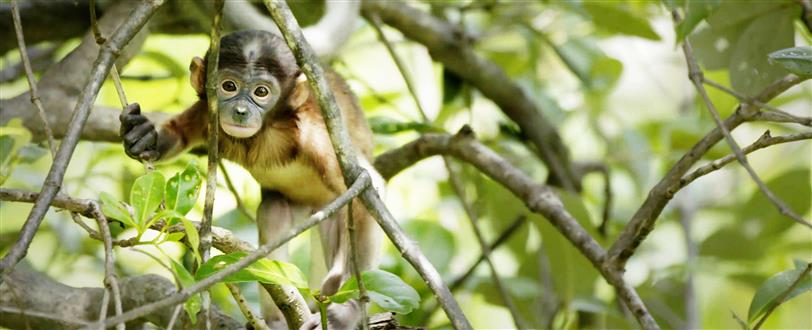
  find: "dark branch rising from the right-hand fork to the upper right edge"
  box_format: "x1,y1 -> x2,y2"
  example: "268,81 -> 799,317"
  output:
606,74 -> 808,269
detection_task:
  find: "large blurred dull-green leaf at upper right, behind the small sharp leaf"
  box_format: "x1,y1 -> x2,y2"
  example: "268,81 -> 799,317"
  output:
728,6 -> 800,95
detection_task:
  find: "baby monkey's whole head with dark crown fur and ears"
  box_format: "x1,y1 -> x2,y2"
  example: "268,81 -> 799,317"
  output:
190,30 -> 300,138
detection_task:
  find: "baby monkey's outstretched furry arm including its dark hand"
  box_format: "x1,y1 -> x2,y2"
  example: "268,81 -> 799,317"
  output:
119,101 -> 208,161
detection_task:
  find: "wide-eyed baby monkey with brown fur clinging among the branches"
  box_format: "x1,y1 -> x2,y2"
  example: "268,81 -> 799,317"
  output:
120,30 -> 383,329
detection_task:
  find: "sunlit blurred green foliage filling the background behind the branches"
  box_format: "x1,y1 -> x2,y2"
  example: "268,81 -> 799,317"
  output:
0,0 -> 812,328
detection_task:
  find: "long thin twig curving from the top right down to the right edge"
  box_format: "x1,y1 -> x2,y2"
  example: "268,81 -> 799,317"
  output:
673,11 -> 812,229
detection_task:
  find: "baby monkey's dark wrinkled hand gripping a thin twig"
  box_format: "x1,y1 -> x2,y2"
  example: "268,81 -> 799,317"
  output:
118,103 -> 160,161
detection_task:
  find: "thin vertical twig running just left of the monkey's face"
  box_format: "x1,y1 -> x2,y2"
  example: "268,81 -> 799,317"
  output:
198,0 -> 225,330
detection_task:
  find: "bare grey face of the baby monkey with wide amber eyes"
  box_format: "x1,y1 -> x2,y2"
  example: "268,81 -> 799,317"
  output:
217,69 -> 281,138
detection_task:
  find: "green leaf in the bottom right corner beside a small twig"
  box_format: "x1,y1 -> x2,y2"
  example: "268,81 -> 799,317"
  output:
747,268 -> 812,322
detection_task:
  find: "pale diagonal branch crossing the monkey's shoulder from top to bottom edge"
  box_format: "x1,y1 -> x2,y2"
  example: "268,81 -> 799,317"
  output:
264,0 -> 471,330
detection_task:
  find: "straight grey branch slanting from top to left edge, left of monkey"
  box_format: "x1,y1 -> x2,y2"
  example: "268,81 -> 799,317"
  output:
0,0 -> 163,276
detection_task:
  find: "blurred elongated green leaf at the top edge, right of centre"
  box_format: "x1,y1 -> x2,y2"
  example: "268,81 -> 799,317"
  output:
583,1 -> 660,40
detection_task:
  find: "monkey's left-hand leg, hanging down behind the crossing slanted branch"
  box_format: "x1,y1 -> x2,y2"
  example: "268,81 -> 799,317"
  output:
257,190 -> 294,328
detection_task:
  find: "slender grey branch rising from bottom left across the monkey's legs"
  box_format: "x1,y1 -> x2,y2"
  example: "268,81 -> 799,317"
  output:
88,173 -> 370,328
